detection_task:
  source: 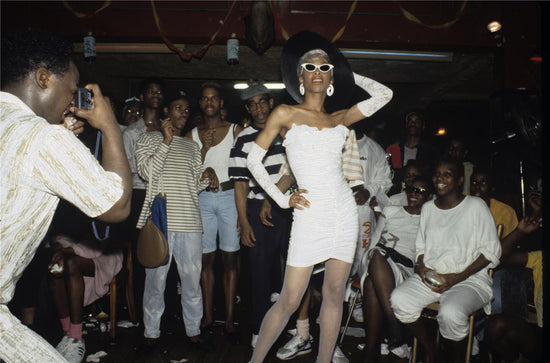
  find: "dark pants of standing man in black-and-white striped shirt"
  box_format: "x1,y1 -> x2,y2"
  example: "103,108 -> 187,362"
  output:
248,199 -> 291,334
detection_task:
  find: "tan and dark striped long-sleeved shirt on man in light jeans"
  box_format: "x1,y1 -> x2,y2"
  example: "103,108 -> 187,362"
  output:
136,131 -> 210,233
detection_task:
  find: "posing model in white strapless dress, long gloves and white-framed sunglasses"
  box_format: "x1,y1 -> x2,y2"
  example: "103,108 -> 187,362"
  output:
247,31 -> 393,363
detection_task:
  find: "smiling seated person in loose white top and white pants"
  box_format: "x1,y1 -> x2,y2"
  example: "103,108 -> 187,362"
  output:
391,159 -> 501,363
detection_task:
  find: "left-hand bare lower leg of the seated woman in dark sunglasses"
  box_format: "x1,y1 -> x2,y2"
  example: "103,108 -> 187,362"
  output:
363,275 -> 382,363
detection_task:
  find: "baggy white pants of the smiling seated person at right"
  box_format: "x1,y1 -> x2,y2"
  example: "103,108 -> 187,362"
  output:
390,274 -> 491,341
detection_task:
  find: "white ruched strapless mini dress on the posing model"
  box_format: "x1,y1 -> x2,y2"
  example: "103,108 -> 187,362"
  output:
283,124 -> 359,267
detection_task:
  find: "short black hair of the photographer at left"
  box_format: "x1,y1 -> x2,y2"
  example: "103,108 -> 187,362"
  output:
0,28 -> 74,85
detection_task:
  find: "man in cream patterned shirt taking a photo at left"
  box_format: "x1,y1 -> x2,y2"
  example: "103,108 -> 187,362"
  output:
0,29 -> 132,362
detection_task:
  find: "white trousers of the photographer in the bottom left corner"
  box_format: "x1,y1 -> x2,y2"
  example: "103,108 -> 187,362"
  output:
0,304 -> 66,363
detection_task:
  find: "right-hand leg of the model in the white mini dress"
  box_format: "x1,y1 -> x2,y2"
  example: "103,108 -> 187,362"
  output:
317,259 -> 351,363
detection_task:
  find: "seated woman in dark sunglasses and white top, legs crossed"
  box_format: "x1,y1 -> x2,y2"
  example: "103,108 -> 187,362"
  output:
361,176 -> 432,362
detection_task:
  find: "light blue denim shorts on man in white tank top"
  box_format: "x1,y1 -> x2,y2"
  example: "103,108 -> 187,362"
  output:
199,189 -> 240,253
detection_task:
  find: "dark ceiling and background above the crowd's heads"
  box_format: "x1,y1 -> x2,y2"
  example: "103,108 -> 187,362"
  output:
1,1 -> 543,182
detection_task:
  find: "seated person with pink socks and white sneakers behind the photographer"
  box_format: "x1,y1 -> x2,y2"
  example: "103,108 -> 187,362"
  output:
49,234 -> 123,362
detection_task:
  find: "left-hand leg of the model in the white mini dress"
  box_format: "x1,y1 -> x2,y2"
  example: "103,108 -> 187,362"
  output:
252,266 -> 313,363
